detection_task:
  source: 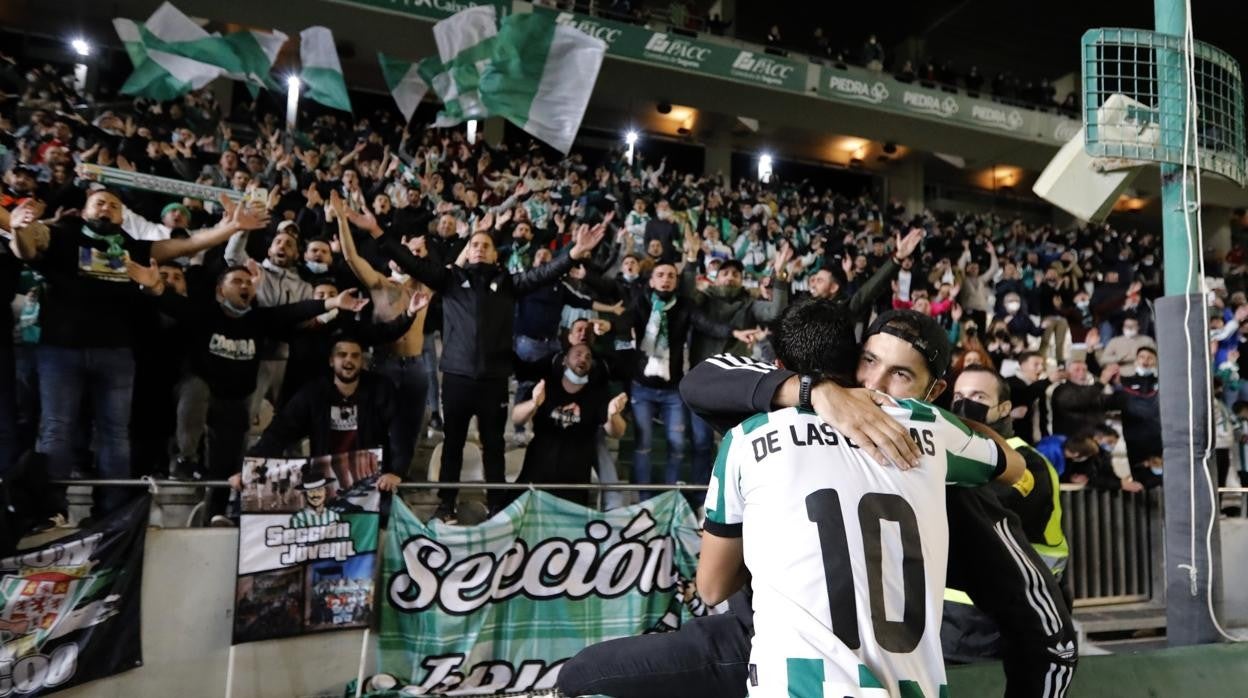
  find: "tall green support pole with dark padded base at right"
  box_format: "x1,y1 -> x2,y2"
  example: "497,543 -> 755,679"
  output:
1153,0 -> 1221,647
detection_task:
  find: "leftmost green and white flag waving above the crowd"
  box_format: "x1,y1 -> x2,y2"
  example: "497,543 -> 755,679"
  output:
112,2 -> 232,101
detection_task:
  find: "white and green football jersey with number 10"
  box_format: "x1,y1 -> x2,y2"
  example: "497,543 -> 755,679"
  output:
705,400 -> 1005,698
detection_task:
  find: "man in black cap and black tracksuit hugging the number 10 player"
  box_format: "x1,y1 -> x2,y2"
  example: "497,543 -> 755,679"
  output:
559,311 -> 1077,698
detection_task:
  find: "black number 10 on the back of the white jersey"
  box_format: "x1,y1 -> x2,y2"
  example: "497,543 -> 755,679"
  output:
806,489 -> 927,654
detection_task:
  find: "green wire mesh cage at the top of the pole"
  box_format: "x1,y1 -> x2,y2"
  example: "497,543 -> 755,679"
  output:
1082,29 -> 1246,186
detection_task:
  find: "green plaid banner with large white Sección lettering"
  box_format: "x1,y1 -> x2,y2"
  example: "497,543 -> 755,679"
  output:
369,491 -> 704,696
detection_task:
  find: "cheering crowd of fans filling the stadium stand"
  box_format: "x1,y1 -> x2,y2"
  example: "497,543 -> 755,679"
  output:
0,50 -> 1248,541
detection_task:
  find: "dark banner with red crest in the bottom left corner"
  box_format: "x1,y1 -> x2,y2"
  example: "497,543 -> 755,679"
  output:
0,494 -> 151,698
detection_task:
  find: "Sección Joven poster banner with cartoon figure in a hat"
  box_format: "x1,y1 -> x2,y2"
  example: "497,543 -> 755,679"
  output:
233,450 -> 382,644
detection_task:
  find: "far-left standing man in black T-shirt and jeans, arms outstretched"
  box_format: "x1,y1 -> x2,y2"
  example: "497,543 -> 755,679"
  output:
10,190 -> 267,514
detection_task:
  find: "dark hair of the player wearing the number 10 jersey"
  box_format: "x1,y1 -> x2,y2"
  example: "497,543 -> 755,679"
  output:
771,298 -> 859,381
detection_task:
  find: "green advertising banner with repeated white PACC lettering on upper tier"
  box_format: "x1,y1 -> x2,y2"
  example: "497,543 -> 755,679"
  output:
533,7 -> 809,92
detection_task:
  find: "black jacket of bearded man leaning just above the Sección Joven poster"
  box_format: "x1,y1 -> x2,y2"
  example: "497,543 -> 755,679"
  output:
250,371 -> 398,472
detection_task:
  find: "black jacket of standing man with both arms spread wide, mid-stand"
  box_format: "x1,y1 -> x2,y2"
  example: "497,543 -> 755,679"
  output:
382,237 -> 575,380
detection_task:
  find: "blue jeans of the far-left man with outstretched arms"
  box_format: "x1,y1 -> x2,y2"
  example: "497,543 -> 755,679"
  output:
36,346 -> 135,516
